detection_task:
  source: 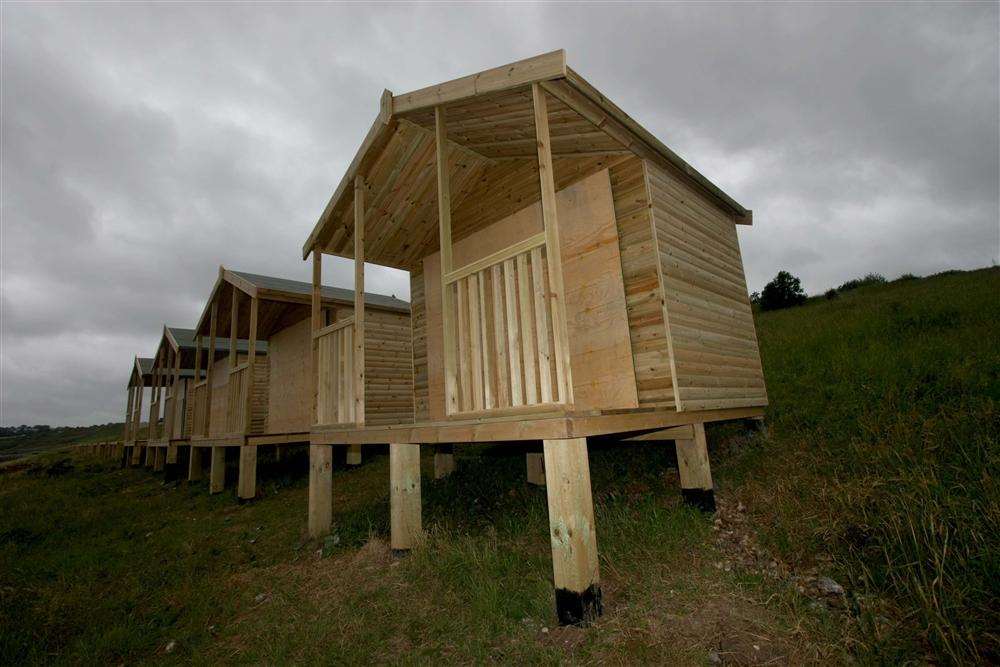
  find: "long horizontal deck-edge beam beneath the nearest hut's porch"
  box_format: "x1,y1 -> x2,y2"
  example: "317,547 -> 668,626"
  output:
310,406 -> 764,445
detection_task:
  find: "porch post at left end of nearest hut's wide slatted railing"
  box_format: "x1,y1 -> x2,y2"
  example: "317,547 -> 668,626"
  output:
434,106 -> 458,415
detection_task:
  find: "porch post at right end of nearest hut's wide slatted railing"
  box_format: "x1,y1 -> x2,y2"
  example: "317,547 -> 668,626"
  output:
531,83 -> 573,403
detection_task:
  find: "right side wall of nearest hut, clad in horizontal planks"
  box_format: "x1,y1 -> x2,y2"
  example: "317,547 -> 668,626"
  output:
645,162 -> 767,411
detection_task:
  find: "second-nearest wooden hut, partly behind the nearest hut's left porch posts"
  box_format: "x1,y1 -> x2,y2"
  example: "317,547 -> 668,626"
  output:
189,267 -> 413,500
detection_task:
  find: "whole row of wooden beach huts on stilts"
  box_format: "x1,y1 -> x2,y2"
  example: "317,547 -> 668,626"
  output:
84,51 -> 767,623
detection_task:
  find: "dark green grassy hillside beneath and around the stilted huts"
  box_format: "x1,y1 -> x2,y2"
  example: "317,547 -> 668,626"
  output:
0,270 -> 1000,664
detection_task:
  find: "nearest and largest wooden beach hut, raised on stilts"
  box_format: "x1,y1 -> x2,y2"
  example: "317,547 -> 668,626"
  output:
303,51 -> 767,623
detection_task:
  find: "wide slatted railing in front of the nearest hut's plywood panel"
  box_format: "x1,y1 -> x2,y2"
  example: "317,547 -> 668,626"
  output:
444,234 -> 566,415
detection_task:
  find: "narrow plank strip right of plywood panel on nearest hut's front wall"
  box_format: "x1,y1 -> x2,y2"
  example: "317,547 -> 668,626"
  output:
610,158 -> 674,407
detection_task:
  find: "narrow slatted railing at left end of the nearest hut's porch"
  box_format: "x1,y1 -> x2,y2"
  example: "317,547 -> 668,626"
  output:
313,317 -> 355,424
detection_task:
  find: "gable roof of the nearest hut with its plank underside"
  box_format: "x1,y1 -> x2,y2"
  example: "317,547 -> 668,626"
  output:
302,50 -> 752,270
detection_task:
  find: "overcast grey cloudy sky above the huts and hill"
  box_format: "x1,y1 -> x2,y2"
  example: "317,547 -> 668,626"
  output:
0,2 -> 1000,425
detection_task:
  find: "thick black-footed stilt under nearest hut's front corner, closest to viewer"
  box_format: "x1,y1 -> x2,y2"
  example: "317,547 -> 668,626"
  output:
543,438 -> 601,625
